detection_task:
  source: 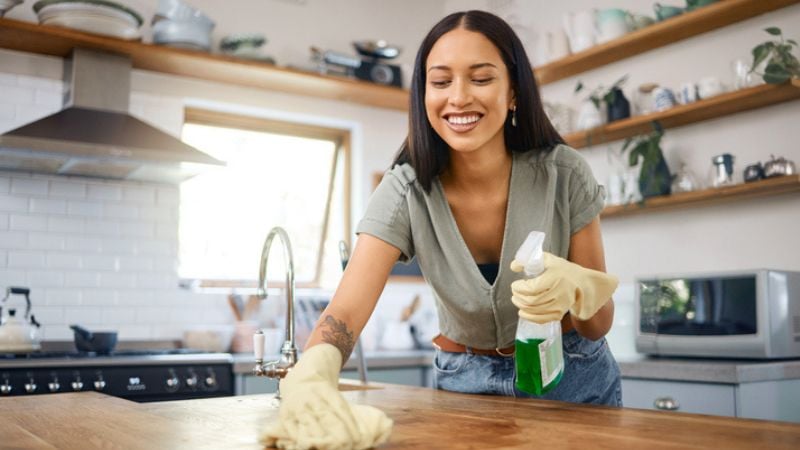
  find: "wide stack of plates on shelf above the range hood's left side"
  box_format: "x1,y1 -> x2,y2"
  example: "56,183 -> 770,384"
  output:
33,0 -> 143,39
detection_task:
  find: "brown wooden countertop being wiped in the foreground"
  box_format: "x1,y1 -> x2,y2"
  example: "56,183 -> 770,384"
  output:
0,384 -> 800,450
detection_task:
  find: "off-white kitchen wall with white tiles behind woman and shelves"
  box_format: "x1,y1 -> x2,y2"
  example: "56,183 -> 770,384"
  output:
0,0 -> 800,352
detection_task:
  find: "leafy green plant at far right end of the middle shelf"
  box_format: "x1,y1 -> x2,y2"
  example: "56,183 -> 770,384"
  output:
750,27 -> 800,84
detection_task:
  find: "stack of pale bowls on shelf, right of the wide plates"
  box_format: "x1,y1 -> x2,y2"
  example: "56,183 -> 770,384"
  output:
153,0 -> 214,51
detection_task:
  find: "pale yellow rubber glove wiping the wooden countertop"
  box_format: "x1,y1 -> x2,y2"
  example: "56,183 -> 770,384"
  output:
261,343 -> 392,450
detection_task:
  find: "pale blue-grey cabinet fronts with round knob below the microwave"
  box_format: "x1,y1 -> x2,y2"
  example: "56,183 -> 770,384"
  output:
622,378 -> 800,422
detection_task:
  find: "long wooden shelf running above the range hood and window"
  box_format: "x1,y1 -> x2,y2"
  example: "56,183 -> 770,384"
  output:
0,18 -> 408,111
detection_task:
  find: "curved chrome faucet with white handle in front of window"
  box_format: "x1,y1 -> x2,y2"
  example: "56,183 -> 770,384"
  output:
253,227 -> 297,398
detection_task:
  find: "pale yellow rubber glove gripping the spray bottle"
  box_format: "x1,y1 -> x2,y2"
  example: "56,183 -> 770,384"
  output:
511,252 -> 619,323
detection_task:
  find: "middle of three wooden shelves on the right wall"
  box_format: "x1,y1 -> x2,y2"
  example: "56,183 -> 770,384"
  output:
564,80 -> 800,148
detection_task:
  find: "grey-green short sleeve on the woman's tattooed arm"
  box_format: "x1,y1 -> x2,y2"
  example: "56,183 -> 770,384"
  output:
356,166 -> 414,262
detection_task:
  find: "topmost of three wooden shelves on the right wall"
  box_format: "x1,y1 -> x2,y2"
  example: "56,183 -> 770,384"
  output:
534,0 -> 800,84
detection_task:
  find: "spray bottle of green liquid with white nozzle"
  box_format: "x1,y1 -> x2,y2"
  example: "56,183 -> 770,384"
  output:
514,231 -> 564,395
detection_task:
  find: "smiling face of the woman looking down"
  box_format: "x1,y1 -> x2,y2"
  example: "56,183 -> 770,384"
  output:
425,28 -> 514,152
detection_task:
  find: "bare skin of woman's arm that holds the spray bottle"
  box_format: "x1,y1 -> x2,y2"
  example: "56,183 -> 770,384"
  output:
567,218 -> 614,340
